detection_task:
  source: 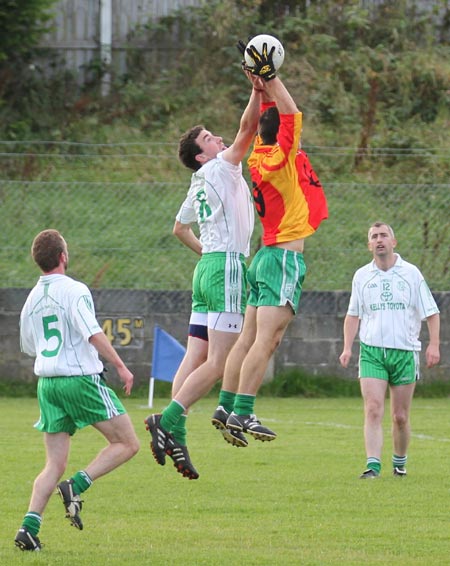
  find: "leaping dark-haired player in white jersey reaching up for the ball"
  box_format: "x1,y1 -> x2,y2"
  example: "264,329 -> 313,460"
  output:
145,73 -> 262,479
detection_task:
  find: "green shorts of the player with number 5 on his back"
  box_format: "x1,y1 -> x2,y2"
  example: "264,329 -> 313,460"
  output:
34,374 -> 126,435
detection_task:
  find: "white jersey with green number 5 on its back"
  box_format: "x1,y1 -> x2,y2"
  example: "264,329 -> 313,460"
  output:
20,274 -> 103,377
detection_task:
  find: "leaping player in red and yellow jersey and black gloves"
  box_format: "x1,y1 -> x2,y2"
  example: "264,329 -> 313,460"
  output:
216,43 -> 328,441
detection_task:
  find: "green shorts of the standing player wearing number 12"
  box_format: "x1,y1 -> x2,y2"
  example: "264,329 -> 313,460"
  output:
359,343 -> 419,385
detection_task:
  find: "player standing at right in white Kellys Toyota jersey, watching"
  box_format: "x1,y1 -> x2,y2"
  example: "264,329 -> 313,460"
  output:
339,222 -> 440,479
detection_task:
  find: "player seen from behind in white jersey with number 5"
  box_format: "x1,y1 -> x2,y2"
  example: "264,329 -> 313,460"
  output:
15,230 -> 139,551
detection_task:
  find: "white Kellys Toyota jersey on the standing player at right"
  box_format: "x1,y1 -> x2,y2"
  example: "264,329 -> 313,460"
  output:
347,254 -> 439,352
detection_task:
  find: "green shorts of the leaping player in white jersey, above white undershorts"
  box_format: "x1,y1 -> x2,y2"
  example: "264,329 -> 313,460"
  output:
192,252 -> 247,314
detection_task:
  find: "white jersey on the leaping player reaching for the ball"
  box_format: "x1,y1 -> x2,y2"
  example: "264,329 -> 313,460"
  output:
176,153 -> 254,257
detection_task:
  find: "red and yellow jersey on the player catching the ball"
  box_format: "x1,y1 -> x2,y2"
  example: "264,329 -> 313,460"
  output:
248,104 -> 328,246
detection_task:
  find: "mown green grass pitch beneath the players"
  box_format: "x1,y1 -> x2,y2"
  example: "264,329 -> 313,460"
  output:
0,397 -> 450,566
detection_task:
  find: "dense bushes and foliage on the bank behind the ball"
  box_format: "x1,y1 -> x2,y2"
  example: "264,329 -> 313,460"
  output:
0,0 -> 450,149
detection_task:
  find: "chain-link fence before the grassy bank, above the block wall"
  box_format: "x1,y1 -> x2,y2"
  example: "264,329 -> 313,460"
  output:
0,142 -> 450,291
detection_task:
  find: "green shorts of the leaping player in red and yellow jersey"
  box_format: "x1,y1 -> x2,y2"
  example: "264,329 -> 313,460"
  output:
247,246 -> 306,313
